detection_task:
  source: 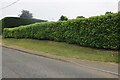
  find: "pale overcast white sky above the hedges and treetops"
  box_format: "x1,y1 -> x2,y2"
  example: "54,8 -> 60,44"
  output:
0,0 -> 119,21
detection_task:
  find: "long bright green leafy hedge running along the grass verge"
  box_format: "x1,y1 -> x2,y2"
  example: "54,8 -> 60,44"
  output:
3,13 -> 120,50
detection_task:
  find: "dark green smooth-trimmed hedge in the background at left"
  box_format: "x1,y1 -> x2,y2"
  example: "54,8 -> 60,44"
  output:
1,17 -> 46,28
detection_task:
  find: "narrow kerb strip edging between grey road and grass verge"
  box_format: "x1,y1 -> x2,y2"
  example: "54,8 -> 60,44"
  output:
2,44 -> 120,76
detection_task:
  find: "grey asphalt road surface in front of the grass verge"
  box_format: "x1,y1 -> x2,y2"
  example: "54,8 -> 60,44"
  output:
2,47 -> 118,78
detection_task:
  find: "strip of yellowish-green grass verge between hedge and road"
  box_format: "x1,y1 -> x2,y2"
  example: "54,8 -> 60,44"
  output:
2,38 -> 118,63
